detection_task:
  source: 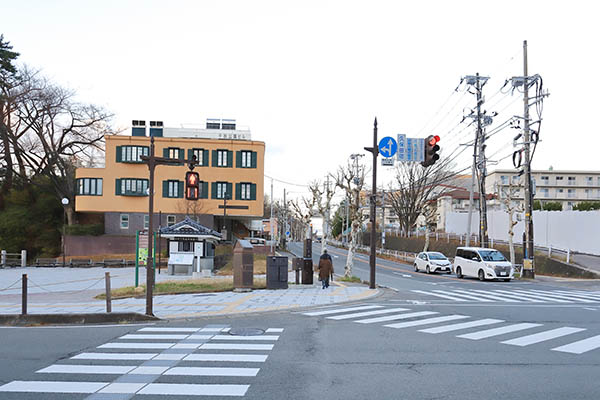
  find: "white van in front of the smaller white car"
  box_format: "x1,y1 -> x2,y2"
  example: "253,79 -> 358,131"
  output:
454,247 -> 514,282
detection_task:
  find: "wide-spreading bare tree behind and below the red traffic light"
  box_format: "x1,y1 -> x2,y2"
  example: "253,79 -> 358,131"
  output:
390,162 -> 455,232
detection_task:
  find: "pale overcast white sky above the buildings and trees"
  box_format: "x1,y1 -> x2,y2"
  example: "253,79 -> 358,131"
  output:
0,0 -> 600,205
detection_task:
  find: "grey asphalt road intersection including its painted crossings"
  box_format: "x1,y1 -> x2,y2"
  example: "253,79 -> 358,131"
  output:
0,242 -> 600,400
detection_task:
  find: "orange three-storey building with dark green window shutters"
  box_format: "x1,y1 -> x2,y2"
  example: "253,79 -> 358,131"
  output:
75,119 -> 265,238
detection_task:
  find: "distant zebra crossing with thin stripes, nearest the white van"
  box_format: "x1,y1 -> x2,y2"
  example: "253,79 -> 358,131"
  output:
411,289 -> 600,304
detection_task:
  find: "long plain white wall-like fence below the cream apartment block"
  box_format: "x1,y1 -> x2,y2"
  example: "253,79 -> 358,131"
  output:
445,211 -> 600,254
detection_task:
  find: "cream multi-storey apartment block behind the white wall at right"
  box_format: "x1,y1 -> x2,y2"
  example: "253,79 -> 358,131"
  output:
486,169 -> 600,210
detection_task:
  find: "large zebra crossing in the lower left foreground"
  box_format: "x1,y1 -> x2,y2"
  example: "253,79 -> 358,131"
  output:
0,326 -> 283,400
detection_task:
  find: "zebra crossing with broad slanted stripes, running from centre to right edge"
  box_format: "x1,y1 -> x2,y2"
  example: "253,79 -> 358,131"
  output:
299,304 -> 600,354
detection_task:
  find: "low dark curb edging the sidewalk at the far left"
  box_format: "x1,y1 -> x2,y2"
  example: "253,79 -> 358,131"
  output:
0,313 -> 160,326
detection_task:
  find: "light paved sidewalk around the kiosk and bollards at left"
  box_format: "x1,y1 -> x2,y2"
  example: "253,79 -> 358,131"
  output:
0,268 -> 381,319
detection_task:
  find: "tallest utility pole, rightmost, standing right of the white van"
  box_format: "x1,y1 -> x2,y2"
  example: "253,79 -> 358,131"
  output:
523,40 -> 539,279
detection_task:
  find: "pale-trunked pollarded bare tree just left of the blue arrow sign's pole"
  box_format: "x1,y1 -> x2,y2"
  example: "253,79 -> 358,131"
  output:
335,158 -> 366,277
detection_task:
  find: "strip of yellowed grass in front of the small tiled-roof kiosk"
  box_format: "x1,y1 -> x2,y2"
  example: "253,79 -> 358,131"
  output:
94,278 -> 267,299
